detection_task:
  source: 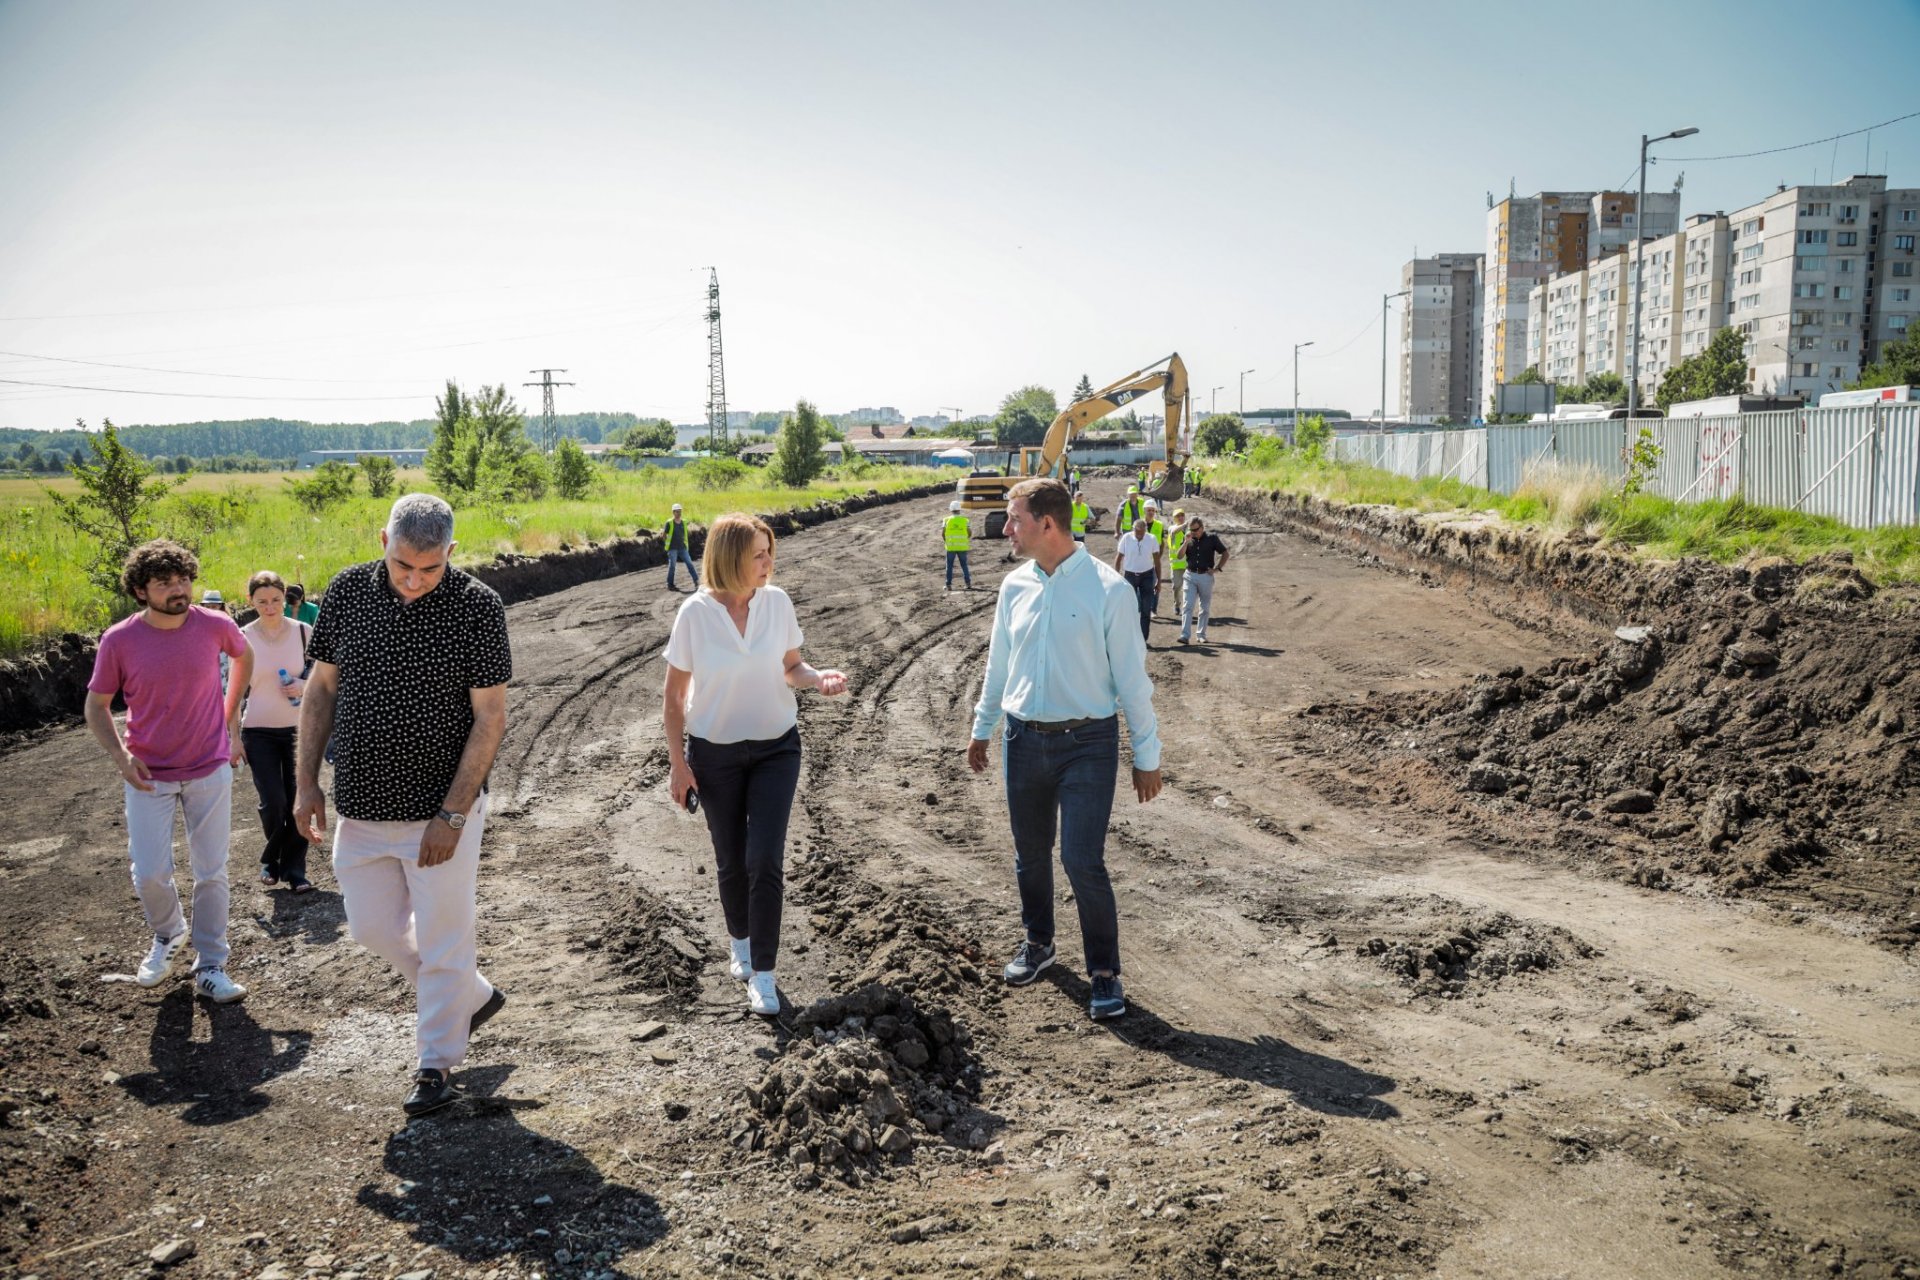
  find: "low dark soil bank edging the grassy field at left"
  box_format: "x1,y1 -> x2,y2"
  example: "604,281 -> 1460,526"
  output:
0,484 -> 948,733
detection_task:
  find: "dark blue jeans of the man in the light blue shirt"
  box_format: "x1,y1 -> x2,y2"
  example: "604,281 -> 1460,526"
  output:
1004,716 -> 1119,975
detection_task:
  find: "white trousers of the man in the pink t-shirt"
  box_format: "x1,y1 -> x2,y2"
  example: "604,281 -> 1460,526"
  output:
125,764 -> 234,973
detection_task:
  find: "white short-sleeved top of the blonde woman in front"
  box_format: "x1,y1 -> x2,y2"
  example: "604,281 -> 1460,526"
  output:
666,587 -> 804,743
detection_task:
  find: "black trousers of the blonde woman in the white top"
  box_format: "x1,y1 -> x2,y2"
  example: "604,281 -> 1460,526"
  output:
687,725 -> 801,971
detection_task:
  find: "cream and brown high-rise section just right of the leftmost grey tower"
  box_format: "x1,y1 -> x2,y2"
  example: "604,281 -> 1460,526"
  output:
1478,192 -> 1597,401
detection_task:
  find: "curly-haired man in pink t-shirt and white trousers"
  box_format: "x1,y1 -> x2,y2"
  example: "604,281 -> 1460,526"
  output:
86,539 -> 253,1004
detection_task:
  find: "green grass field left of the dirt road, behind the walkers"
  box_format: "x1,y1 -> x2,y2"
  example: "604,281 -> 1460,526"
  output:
0,466 -> 952,656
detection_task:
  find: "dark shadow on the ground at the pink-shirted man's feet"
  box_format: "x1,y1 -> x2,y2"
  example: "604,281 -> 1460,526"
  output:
119,983 -> 313,1125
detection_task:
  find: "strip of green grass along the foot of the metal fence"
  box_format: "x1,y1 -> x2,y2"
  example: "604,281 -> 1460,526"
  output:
1208,453 -> 1920,583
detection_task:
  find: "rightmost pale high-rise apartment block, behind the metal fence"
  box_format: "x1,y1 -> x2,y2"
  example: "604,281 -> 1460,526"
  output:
1728,175 -> 1920,397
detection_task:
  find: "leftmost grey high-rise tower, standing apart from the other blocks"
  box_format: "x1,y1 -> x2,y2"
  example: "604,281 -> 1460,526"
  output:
1400,253 -> 1484,422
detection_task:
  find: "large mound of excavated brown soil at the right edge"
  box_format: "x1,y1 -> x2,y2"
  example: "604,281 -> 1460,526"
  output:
1309,553 -> 1920,946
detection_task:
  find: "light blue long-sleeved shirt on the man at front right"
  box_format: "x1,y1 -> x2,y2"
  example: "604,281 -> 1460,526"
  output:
973,547 -> 1160,770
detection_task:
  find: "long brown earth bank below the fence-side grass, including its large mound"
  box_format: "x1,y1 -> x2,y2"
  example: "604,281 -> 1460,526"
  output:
1235,485 -> 1920,948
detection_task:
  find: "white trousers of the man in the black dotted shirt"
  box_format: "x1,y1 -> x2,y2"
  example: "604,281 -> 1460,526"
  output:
334,793 -> 493,1071
